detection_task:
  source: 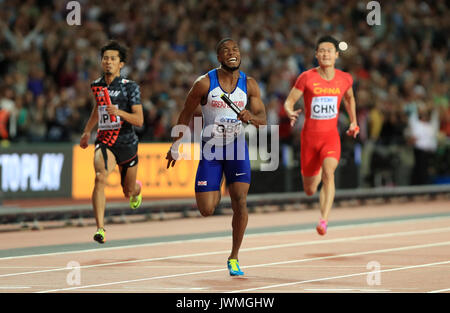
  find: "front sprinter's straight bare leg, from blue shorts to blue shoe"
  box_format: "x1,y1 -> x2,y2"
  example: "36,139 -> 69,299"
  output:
229,182 -> 250,259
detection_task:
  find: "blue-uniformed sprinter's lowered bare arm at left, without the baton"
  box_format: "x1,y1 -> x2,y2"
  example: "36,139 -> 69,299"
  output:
166,75 -> 209,168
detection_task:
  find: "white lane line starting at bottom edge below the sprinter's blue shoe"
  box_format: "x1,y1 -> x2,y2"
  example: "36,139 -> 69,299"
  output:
228,258 -> 450,293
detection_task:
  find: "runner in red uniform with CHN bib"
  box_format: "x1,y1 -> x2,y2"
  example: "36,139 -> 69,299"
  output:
284,36 -> 359,235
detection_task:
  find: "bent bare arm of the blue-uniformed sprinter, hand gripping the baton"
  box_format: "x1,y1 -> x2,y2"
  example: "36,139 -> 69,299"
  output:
238,77 -> 267,127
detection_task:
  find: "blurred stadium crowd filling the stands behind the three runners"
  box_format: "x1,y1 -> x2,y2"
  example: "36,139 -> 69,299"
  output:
0,0 -> 450,186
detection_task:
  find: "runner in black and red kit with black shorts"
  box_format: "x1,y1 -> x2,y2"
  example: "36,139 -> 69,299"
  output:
80,41 -> 144,243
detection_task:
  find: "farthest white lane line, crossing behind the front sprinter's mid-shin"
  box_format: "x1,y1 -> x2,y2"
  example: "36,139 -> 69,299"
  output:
0,216 -> 447,262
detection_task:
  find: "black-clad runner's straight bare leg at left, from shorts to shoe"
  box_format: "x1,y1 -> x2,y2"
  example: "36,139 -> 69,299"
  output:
92,148 -> 116,228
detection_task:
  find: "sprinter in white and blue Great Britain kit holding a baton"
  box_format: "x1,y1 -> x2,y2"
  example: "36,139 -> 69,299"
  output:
166,38 -> 266,276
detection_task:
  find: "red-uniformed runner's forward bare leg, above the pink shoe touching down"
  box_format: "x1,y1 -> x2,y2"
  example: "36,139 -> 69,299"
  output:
320,158 -> 338,221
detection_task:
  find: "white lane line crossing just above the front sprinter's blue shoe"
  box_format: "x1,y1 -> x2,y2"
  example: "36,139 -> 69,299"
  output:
0,227 -> 450,278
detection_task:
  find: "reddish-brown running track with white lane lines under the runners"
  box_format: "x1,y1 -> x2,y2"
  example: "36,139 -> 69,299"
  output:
0,200 -> 450,293
